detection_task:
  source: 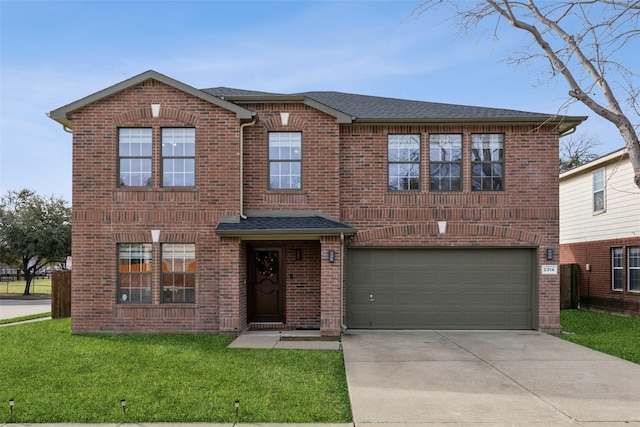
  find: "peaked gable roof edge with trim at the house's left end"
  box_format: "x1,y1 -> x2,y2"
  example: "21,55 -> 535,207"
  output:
47,70 -> 253,128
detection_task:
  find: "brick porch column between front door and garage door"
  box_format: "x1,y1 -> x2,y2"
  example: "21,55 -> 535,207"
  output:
320,236 -> 342,336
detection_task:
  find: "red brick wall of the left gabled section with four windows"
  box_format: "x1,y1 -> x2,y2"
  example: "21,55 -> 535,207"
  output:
72,80 -> 239,333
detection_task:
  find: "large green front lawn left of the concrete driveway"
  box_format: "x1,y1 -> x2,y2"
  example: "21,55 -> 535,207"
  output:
0,319 -> 352,424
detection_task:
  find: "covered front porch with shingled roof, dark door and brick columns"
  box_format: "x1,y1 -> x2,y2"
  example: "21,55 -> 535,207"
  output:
216,211 -> 355,337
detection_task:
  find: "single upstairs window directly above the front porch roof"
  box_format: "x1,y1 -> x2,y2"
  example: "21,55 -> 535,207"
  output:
269,132 -> 302,190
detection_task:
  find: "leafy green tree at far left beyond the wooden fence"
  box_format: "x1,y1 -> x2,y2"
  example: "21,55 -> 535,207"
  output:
0,189 -> 71,295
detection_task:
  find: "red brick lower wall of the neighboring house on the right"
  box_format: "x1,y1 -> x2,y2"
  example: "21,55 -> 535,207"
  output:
560,237 -> 640,317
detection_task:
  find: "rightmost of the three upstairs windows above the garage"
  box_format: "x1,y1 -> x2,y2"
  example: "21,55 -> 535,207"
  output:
471,133 -> 504,191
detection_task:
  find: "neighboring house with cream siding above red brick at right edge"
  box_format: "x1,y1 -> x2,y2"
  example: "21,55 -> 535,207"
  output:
560,149 -> 640,316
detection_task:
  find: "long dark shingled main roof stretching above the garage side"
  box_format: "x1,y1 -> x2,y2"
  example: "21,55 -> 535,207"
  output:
203,87 -> 587,133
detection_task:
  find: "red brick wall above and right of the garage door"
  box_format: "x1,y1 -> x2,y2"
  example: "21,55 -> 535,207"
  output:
340,125 -> 560,330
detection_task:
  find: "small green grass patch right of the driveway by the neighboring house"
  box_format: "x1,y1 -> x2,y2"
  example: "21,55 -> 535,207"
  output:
560,310 -> 640,364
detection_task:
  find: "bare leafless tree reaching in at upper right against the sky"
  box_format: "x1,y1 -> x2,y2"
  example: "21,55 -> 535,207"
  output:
414,0 -> 640,188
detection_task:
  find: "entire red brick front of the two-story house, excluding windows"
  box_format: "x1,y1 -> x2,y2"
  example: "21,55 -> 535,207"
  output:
55,72 -> 572,335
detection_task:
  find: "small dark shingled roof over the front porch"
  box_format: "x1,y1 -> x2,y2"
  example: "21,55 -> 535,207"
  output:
216,211 -> 357,240
